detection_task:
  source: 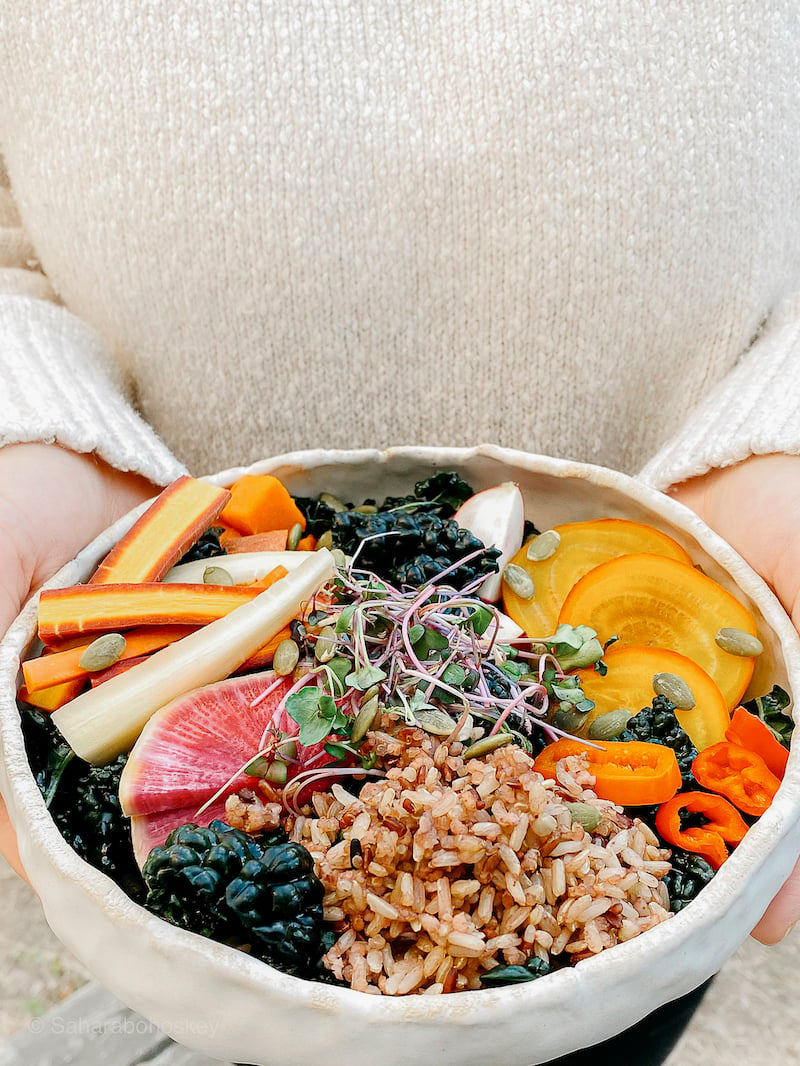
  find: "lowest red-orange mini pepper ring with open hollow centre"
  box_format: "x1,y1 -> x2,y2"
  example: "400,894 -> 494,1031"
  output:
656,792 -> 748,870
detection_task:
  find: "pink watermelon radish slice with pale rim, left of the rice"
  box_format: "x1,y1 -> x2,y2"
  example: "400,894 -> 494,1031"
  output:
119,672 -> 332,863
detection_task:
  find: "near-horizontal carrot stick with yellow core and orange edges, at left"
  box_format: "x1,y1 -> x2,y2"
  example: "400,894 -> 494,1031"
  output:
38,582 -> 259,644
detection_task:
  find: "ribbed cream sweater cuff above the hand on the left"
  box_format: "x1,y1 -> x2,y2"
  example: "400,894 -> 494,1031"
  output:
0,296 -> 185,485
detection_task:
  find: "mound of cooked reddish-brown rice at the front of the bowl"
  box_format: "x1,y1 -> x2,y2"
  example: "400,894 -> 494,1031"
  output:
290,715 -> 670,996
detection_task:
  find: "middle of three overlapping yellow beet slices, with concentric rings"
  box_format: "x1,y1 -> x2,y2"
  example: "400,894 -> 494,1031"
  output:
558,554 -> 756,710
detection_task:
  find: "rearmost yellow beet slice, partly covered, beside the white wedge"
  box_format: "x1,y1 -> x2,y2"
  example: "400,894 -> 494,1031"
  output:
502,518 -> 691,637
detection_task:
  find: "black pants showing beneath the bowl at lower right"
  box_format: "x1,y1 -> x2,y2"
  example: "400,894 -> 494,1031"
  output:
240,981 -> 711,1066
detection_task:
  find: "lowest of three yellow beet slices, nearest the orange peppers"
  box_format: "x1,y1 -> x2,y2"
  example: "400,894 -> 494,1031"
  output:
577,644 -> 731,752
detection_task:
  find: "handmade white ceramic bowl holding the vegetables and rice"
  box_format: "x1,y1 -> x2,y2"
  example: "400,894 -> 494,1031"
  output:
0,447 -> 800,1066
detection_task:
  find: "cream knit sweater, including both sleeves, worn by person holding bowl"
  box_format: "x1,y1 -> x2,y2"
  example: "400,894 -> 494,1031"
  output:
0,6 -> 800,487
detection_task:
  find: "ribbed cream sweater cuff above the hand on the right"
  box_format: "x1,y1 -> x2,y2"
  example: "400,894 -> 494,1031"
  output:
640,293 -> 800,490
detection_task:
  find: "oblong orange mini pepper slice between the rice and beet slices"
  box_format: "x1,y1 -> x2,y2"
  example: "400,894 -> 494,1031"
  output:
533,738 -> 681,807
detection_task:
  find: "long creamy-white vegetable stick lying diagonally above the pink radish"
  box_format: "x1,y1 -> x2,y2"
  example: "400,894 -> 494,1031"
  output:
52,548 -> 335,765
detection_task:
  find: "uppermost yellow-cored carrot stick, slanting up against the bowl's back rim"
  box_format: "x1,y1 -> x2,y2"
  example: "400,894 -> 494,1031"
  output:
90,477 -> 230,584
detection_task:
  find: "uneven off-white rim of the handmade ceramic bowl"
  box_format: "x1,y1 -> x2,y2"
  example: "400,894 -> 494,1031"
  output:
0,446 -> 800,1050
